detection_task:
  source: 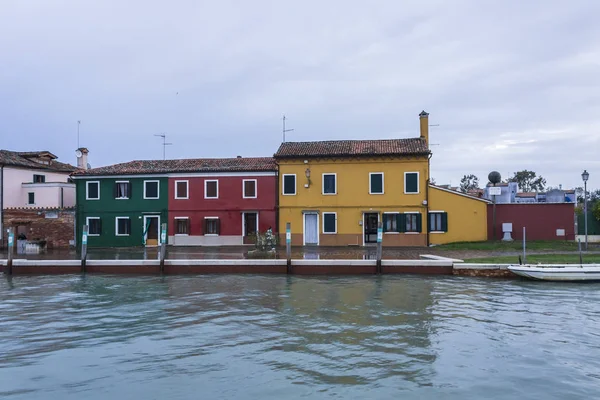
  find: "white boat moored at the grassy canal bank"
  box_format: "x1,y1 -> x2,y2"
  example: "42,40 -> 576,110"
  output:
508,264 -> 600,282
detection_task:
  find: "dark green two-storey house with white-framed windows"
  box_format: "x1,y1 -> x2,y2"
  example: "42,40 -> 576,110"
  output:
73,174 -> 168,247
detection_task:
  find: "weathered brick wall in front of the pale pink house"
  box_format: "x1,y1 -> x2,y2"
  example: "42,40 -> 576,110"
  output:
2,208 -> 75,249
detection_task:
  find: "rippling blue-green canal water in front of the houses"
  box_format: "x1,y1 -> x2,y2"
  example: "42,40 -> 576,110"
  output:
0,275 -> 600,400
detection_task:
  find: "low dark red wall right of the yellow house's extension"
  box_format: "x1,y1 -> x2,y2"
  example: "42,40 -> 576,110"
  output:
488,203 -> 575,240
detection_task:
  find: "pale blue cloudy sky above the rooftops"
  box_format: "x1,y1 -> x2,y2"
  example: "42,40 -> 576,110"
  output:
0,0 -> 600,188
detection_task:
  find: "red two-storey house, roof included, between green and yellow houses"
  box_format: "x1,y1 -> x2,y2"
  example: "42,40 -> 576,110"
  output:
168,157 -> 277,246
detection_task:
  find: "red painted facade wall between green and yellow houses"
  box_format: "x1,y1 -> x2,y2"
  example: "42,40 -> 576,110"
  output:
169,175 -> 277,236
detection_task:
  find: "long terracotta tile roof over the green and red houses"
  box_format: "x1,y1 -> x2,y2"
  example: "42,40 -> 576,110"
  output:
74,157 -> 276,175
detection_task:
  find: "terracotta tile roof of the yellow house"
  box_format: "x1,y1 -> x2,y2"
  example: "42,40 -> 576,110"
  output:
275,138 -> 429,158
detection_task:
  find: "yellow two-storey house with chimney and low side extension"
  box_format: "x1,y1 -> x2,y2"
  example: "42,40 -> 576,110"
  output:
274,111 -> 487,246
